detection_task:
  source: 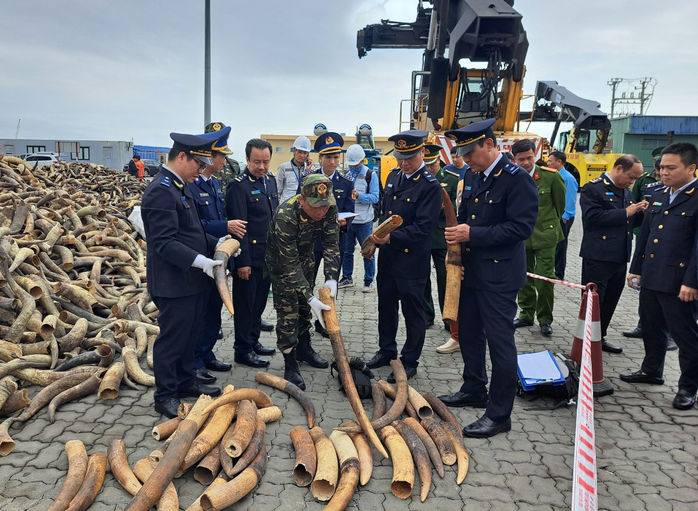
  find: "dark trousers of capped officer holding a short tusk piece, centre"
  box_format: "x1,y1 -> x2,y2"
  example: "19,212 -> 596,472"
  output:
376,271 -> 427,367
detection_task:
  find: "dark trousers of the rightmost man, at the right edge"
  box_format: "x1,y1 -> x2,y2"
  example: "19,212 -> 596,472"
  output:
640,288 -> 698,394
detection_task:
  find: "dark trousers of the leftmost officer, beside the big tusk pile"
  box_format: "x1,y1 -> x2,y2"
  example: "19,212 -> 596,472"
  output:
153,289 -> 209,401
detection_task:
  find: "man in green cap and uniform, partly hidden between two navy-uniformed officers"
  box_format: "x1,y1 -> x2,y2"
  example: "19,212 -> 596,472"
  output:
424,144 -> 460,328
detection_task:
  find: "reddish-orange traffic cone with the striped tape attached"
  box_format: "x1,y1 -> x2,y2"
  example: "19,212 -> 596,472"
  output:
570,286 -> 613,397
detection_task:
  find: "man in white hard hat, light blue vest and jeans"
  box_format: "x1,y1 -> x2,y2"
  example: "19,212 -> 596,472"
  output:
339,144 -> 379,293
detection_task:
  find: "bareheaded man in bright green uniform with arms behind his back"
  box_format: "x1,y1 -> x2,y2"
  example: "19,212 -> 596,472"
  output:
511,138 -> 565,336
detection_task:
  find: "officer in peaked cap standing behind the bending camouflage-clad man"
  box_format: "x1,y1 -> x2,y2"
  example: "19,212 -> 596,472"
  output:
312,131 -> 354,342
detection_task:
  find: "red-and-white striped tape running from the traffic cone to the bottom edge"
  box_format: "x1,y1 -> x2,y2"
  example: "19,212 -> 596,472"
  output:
572,292 -> 599,511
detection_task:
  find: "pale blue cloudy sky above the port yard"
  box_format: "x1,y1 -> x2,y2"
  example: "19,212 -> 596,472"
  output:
0,0 -> 698,155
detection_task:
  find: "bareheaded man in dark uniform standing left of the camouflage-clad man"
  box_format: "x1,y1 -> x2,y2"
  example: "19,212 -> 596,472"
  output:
226,138 -> 279,367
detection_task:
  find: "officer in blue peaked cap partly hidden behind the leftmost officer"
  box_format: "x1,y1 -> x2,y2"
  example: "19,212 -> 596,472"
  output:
187,123 -> 244,383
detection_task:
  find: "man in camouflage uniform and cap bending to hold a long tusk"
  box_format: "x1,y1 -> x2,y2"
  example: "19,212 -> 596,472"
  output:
265,174 -> 339,390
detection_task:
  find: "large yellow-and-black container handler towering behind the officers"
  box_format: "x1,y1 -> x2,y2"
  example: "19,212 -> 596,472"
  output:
357,0 -> 543,188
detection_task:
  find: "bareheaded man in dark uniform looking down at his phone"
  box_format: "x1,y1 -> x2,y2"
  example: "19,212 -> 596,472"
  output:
579,154 -> 647,353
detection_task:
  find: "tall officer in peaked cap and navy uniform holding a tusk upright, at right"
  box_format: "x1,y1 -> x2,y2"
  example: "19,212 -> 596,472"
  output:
439,119 -> 538,438
